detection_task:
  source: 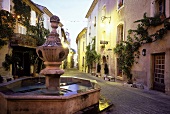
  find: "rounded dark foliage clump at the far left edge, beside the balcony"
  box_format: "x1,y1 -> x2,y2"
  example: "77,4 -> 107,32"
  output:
0,10 -> 15,48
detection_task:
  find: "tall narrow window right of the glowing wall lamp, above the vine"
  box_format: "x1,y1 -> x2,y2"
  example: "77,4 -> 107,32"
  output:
117,24 -> 123,43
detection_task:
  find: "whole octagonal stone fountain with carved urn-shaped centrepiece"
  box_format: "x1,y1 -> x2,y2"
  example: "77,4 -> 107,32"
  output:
0,16 -> 100,114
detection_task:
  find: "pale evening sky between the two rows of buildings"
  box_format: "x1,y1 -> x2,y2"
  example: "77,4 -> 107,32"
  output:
32,0 -> 93,51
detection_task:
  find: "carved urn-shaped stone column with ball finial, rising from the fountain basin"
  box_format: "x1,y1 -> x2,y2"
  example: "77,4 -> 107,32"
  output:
36,15 -> 69,93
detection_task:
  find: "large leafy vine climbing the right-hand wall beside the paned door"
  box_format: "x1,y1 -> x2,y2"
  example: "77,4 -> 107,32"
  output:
114,13 -> 170,80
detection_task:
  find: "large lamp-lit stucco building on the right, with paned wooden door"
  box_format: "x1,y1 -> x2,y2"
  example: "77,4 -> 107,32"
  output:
86,0 -> 170,93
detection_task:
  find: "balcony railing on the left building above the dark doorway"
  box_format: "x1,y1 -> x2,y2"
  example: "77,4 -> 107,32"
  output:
10,33 -> 36,47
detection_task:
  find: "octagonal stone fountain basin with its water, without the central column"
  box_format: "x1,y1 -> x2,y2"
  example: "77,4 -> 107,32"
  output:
0,77 -> 100,114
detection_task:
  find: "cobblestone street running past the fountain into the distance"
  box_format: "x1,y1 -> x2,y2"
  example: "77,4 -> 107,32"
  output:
63,69 -> 170,114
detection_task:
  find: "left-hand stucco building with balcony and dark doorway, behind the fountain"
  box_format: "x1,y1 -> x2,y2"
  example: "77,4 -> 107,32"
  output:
0,0 -> 67,81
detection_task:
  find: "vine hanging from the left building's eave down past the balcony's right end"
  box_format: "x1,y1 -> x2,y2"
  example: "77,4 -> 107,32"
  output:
13,0 -> 50,46
